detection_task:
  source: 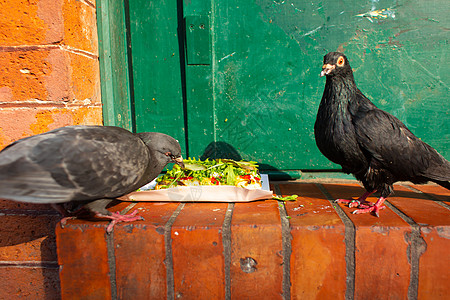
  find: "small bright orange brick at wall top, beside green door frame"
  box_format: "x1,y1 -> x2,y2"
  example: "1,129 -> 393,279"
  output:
62,0 -> 98,54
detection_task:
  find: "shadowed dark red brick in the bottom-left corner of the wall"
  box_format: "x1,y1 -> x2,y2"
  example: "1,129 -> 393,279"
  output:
0,266 -> 61,300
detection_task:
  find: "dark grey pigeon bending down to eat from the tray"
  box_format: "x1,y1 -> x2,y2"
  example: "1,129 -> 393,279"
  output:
0,126 -> 183,232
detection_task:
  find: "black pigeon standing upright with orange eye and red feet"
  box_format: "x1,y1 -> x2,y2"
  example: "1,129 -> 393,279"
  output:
314,52 -> 450,216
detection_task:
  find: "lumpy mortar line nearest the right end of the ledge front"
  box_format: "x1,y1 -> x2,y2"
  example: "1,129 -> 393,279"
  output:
384,200 -> 426,300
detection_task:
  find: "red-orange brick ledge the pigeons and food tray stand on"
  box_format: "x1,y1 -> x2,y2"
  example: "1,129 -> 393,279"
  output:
56,183 -> 450,299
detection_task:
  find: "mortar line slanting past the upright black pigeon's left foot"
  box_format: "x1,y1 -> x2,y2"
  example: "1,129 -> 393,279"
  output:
315,183 -> 356,300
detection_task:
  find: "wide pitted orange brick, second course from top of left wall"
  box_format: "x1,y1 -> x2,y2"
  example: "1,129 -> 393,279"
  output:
0,46 -> 100,103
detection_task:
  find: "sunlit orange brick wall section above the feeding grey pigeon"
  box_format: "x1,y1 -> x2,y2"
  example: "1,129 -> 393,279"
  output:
0,0 -> 102,149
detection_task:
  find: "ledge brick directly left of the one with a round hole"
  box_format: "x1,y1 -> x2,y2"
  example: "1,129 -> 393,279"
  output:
172,203 -> 228,299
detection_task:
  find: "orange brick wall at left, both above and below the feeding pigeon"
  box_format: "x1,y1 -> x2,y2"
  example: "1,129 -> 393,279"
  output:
0,0 -> 102,299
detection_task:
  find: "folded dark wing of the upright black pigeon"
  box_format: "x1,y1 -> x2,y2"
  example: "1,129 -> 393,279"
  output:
353,99 -> 450,181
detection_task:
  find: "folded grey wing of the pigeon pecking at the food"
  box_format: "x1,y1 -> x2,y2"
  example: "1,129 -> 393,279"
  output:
0,127 -> 149,203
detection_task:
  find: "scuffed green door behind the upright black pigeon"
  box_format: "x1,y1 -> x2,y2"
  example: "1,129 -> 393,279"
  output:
99,0 -> 450,174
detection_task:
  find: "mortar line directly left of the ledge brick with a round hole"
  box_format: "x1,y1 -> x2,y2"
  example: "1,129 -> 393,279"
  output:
222,203 -> 234,300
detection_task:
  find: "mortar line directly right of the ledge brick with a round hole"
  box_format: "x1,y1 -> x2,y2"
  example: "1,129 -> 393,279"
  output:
274,184 -> 292,300
